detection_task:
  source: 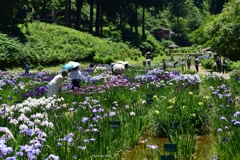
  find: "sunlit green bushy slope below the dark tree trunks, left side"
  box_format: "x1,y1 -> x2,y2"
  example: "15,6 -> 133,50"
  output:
0,22 -> 144,70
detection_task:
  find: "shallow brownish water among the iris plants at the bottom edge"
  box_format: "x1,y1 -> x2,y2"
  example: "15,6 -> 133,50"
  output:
122,136 -> 212,160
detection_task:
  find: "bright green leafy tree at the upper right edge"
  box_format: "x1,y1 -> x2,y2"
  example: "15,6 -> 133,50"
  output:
192,0 -> 240,60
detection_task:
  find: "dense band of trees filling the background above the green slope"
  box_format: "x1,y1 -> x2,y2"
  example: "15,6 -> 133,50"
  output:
0,0 -> 238,58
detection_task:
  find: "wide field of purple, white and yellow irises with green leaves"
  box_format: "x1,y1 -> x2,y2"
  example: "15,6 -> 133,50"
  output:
0,65 -> 240,160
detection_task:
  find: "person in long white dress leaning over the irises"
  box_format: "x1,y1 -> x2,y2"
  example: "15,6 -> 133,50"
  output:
47,71 -> 68,98
